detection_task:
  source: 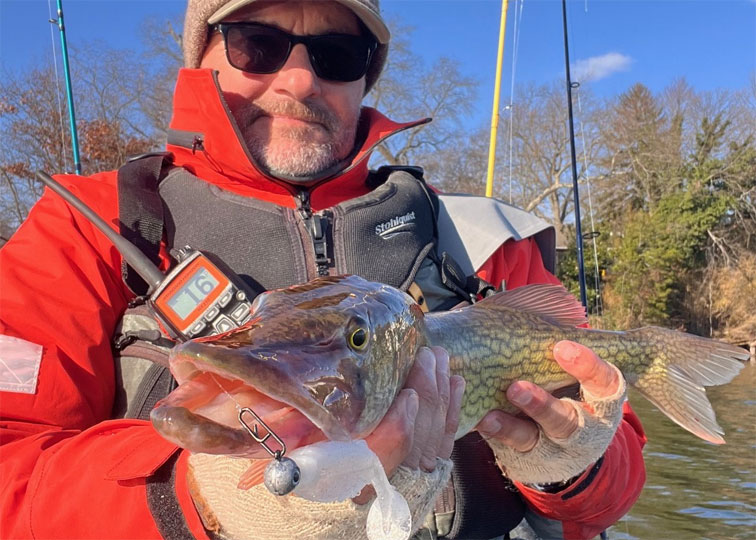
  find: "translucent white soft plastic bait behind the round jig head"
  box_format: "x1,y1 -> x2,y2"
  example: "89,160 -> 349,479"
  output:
288,440 -> 412,540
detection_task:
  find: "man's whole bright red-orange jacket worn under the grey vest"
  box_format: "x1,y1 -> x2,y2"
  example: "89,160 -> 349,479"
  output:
0,70 -> 645,538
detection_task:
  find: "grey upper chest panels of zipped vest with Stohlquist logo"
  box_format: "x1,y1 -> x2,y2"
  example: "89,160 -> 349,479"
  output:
159,168 -> 437,294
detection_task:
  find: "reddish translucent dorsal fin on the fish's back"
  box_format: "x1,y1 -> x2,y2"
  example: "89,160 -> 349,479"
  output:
475,284 -> 588,326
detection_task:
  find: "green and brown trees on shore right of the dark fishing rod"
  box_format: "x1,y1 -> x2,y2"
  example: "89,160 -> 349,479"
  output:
560,85 -> 756,347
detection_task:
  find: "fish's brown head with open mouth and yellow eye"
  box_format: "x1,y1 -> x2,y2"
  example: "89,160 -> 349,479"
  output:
151,276 -> 425,455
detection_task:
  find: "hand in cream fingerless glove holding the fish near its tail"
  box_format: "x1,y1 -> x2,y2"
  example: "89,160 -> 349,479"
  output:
476,341 -> 625,483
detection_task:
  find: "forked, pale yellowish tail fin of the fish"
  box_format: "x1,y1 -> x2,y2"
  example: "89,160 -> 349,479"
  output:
625,326 -> 748,444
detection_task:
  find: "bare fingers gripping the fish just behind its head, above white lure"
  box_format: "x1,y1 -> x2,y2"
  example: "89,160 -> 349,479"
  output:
366,347 -> 465,476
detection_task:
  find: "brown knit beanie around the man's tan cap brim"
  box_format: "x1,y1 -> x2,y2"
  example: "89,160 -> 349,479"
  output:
183,0 -> 391,94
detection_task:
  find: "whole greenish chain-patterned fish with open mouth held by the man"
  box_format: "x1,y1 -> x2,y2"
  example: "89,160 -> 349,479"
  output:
150,275 -> 748,487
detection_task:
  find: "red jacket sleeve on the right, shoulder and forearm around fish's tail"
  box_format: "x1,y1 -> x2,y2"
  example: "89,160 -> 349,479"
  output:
478,238 -> 646,540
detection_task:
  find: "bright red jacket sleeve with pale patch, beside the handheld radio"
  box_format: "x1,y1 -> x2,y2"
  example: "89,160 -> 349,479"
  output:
0,175 -> 207,538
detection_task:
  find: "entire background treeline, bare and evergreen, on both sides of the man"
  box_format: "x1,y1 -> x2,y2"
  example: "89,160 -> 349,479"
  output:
0,16 -> 756,346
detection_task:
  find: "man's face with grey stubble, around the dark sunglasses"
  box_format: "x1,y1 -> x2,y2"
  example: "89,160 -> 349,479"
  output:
200,2 -> 365,176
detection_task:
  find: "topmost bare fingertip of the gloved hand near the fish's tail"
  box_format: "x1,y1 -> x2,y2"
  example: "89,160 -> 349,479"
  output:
554,341 -> 620,398
